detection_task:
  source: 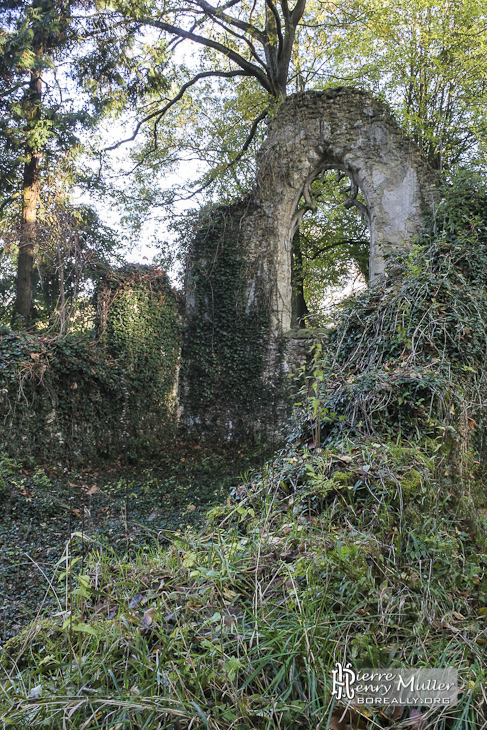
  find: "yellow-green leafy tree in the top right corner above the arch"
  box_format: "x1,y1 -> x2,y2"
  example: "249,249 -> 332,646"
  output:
333,0 -> 487,172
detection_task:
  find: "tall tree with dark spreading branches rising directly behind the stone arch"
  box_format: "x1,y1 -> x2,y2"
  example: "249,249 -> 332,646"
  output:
80,0 -> 370,298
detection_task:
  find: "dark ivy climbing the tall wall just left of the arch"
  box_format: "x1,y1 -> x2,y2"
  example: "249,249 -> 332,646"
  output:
181,202 -> 272,436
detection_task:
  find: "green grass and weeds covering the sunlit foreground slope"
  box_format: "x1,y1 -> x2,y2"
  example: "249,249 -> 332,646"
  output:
0,432 -> 487,730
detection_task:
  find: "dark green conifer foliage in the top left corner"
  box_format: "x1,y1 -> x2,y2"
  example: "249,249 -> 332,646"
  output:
0,0 -> 92,212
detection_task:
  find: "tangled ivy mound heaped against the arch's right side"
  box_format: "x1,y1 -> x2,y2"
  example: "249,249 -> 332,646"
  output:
290,175 -> 487,460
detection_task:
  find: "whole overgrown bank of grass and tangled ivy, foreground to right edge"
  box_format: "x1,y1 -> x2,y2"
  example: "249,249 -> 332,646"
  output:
0,173 -> 487,730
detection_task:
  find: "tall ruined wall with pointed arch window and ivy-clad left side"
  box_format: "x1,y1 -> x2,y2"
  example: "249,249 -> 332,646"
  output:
181,87 -> 437,436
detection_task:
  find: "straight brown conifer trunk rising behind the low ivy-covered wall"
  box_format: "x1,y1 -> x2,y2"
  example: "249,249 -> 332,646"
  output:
13,71 -> 42,329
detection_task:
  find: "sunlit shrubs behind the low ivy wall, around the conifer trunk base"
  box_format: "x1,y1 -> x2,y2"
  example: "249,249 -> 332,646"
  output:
0,199 -> 126,335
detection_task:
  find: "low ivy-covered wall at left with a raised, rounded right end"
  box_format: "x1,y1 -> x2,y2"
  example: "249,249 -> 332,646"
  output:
0,267 -> 181,460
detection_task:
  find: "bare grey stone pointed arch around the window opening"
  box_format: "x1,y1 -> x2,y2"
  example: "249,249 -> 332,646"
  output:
248,88 -> 436,331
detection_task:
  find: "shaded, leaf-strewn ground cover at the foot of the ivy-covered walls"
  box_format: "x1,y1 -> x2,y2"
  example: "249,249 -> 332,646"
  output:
0,442 -> 262,643
